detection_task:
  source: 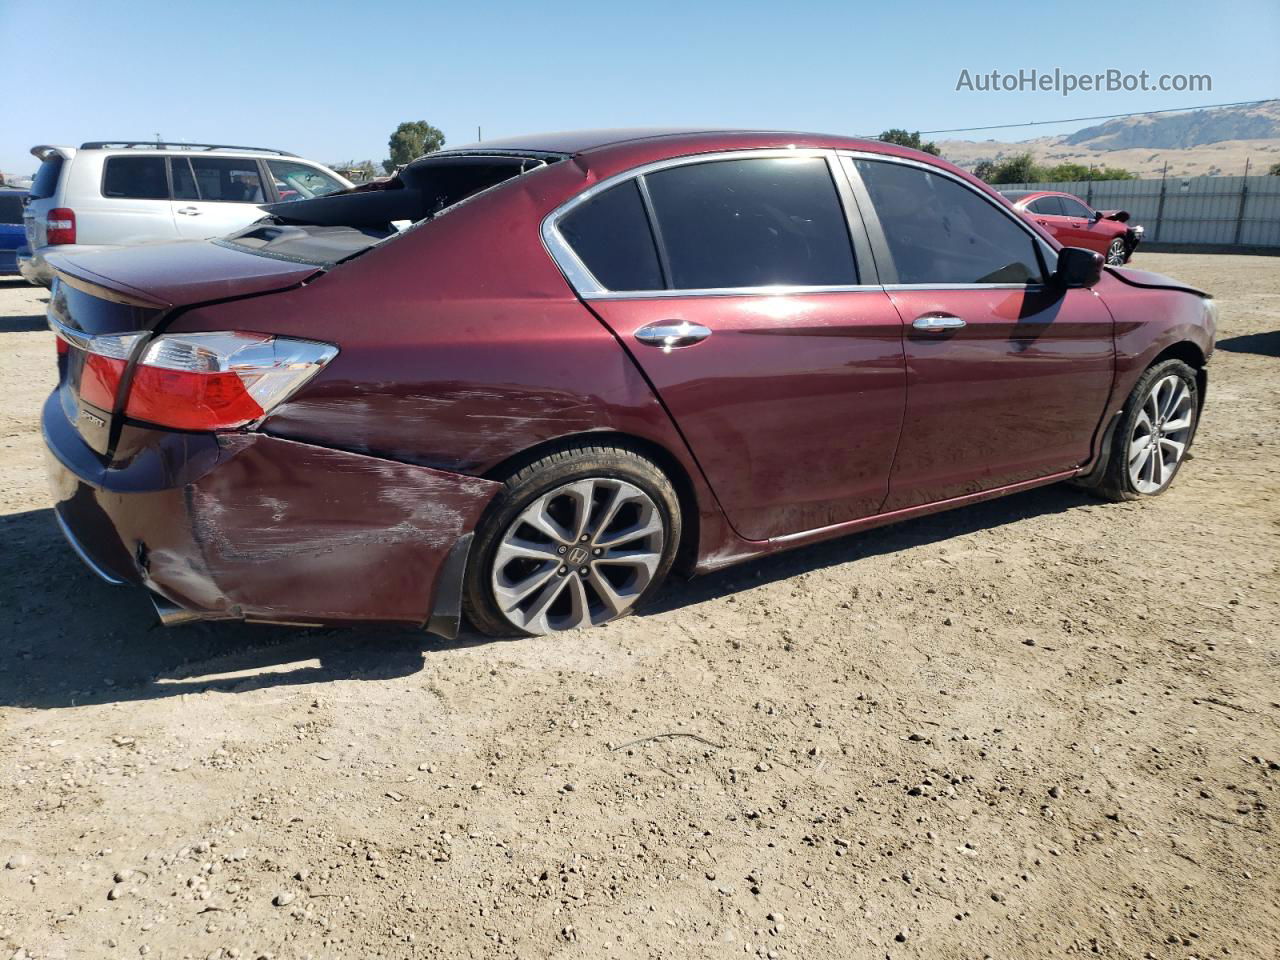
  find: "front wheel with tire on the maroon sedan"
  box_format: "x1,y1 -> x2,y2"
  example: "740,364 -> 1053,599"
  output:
1092,360 -> 1199,500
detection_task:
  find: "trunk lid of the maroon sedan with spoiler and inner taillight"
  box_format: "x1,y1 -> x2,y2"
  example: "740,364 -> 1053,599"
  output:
47,241 -> 321,460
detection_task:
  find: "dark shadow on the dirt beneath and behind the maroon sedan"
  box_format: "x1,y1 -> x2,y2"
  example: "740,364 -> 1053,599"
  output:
0,484 -> 1096,709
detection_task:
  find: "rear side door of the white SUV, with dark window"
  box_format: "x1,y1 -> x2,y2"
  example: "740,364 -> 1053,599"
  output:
169,155 -> 270,239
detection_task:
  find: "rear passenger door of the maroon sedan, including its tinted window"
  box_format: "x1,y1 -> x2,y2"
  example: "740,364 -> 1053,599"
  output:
548,151 -> 905,540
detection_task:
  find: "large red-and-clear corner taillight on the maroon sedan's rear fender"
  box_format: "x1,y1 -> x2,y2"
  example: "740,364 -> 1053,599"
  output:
124,333 -> 338,430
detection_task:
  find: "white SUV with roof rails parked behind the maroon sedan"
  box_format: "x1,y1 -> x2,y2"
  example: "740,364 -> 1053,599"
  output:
18,141 -> 352,287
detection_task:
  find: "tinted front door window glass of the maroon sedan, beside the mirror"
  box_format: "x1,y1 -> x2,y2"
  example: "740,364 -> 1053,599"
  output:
856,160 -> 1043,284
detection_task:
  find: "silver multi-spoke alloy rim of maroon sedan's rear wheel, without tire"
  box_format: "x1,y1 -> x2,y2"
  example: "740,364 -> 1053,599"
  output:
490,477 -> 666,634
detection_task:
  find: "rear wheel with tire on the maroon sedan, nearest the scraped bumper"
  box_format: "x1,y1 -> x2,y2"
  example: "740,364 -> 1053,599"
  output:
462,444 -> 681,636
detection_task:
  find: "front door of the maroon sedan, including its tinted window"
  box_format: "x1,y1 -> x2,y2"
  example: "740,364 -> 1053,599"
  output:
852,160 -> 1115,511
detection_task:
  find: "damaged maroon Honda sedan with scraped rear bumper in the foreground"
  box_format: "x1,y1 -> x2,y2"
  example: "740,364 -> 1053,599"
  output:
44,132 -> 1215,636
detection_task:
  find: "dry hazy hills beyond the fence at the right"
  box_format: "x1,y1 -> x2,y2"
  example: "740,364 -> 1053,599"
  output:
938,104 -> 1280,177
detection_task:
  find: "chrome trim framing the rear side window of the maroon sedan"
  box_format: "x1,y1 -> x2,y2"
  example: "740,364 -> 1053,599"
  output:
541,147 -> 879,300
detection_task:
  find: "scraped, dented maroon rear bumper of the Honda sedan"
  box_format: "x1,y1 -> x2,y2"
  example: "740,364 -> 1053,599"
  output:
42,396 -> 498,632
